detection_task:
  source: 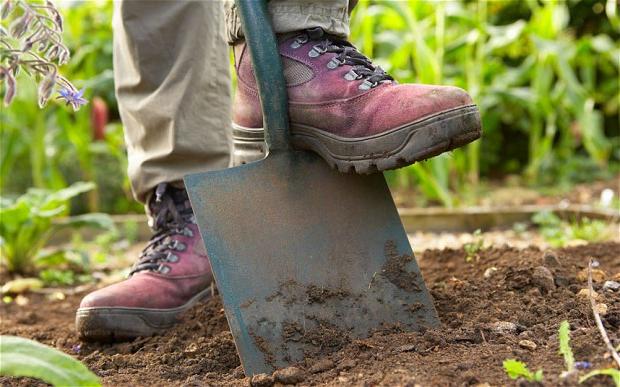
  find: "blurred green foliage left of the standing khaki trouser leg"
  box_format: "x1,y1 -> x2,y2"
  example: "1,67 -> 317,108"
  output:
0,1 -> 143,213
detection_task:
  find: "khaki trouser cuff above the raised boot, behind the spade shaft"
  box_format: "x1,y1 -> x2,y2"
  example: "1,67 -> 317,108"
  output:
226,0 -> 357,44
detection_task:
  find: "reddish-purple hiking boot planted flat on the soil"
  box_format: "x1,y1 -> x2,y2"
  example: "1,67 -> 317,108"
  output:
76,184 -> 213,341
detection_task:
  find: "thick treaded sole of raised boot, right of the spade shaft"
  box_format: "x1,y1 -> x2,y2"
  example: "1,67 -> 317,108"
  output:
291,105 -> 482,174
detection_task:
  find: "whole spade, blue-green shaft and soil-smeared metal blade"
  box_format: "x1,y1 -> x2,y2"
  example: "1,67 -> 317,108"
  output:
185,1 -> 438,375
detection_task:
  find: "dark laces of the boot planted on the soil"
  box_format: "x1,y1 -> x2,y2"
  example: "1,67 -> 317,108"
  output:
129,183 -> 195,276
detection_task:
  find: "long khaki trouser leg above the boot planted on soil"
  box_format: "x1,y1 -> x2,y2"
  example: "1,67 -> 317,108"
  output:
114,0 -> 231,202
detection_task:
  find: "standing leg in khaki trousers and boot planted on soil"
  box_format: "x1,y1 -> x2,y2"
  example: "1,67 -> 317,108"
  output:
76,0 -> 231,340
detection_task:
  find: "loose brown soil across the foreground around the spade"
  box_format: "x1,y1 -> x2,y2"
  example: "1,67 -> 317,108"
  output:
0,243 -> 620,386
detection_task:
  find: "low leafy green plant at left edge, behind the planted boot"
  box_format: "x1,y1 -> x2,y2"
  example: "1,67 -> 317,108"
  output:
0,182 -> 114,273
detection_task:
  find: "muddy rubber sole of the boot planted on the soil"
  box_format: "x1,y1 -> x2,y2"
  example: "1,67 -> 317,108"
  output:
75,287 -> 212,341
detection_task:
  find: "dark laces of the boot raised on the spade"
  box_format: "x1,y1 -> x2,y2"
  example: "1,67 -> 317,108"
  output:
291,28 -> 394,90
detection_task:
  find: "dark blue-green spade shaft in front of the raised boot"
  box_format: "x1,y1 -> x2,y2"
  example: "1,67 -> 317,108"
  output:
235,0 -> 290,153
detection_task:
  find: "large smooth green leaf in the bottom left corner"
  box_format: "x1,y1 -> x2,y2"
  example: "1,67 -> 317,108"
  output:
0,336 -> 101,386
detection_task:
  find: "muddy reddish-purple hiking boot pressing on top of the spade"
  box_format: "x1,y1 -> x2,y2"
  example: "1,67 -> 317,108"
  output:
233,28 -> 481,173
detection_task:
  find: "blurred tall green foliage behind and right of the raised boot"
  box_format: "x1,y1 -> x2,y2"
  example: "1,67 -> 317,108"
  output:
351,0 -> 620,206
